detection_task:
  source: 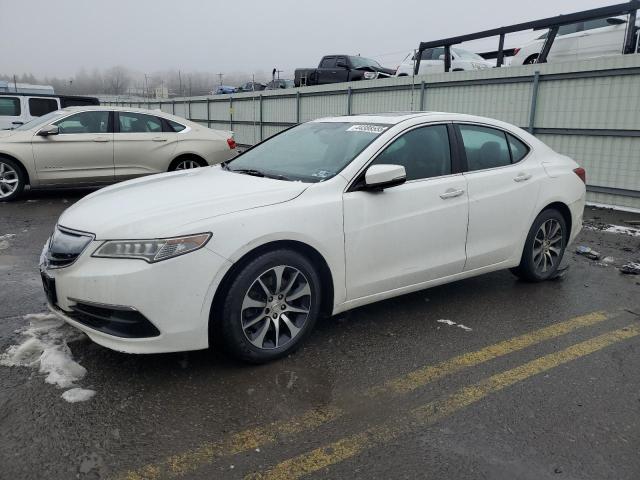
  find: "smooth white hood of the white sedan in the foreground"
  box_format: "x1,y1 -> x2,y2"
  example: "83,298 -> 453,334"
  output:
58,166 -> 309,240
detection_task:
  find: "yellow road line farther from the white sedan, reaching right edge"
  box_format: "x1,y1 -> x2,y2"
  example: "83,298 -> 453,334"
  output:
245,324 -> 640,480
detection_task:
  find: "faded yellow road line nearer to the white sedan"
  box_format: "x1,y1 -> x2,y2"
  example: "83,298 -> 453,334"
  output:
117,312 -> 609,480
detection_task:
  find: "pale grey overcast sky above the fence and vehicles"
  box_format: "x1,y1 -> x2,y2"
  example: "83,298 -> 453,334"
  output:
0,0 -> 621,76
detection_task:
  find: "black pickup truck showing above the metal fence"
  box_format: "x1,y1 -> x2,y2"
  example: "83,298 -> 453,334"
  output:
294,55 -> 396,87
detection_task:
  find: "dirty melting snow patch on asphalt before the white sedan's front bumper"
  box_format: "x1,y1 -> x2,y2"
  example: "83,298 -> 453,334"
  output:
0,313 -> 93,401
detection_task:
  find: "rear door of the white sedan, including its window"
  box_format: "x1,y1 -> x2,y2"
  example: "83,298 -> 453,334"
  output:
456,123 -> 546,271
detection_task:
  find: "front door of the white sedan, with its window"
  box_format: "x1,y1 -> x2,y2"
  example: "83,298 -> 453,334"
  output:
343,124 -> 468,300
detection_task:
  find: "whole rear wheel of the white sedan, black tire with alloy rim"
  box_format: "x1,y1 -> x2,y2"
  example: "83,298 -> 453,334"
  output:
511,208 -> 568,282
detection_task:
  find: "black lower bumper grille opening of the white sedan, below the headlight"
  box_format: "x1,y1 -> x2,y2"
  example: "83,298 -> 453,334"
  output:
64,300 -> 160,338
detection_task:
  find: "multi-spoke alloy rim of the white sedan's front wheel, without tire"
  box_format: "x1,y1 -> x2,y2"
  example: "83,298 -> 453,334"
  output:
240,265 -> 311,350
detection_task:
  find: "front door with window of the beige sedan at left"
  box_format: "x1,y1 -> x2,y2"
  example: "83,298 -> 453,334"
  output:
32,110 -> 114,185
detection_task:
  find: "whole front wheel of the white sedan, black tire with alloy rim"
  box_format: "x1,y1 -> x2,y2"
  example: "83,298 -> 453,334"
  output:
218,249 -> 322,363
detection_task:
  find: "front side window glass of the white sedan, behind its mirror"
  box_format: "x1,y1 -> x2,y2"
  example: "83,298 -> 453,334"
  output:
372,125 -> 451,180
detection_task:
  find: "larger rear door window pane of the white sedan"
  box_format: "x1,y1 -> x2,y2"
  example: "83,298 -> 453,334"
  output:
459,125 -> 511,172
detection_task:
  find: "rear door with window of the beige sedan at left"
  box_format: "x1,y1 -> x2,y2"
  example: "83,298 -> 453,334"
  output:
114,112 -> 178,181
